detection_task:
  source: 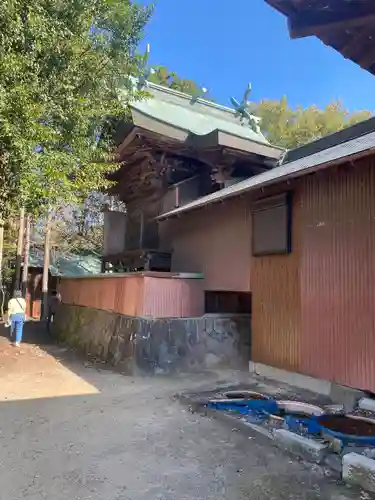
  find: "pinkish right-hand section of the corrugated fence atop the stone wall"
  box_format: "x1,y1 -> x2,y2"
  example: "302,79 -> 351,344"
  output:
143,277 -> 204,318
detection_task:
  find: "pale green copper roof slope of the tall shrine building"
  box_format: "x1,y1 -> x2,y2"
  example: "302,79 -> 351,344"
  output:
131,82 -> 268,145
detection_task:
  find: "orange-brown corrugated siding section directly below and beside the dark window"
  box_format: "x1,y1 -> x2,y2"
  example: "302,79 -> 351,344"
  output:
251,191 -> 301,371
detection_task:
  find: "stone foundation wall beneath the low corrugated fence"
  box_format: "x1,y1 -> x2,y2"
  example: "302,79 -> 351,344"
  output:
54,304 -> 251,374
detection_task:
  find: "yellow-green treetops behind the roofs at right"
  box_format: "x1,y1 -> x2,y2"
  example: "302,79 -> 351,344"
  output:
252,97 -> 372,149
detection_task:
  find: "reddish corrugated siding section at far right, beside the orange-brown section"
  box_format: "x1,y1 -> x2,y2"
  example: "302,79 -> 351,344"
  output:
300,159 -> 375,391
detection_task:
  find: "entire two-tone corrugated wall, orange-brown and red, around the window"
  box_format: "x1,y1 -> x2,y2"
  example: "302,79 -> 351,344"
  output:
251,159 -> 375,392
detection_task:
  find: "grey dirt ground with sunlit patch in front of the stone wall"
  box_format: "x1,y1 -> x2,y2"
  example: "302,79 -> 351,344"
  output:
0,326 -> 368,500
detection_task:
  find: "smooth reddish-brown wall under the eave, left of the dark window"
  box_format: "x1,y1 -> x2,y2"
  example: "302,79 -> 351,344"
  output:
161,198 -> 251,292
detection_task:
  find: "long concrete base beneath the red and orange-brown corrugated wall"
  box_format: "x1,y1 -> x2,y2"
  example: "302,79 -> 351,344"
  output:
249,361 -> 366,412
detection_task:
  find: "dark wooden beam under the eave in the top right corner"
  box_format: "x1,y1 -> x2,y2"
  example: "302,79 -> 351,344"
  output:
288,2 -> 375,38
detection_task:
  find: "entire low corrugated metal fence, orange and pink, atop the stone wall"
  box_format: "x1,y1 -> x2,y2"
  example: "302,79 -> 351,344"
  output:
60,274 -> 204,318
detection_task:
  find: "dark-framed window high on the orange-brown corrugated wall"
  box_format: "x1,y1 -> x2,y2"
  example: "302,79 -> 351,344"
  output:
251,193 -> 292,256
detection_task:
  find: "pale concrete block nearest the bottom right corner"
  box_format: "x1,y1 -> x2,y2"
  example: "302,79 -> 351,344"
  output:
342,453 -> 375,493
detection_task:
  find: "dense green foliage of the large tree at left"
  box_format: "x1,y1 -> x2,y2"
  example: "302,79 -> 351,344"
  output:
0,0 -> 151,214
